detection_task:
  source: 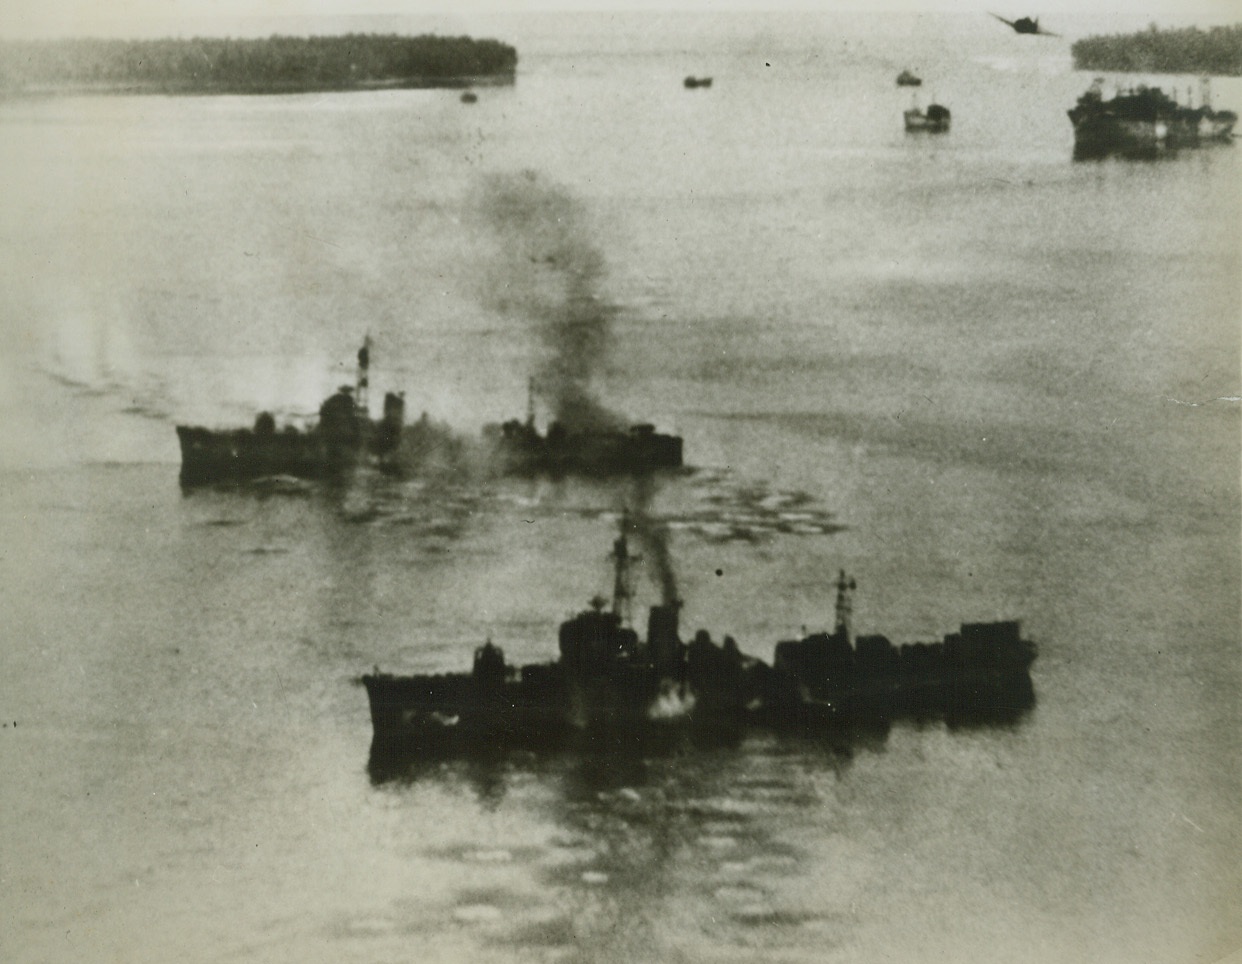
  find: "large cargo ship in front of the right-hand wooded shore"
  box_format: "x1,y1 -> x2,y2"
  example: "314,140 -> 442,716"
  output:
1068,77 -> 1238,158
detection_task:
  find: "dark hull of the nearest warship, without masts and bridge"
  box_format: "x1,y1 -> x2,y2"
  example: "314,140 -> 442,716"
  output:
361,624 -> 1036,768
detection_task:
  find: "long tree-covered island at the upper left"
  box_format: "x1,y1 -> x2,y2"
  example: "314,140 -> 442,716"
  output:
0,34 -> 518,92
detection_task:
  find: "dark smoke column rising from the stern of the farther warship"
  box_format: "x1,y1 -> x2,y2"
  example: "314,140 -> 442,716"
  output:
474,171 -> 625,431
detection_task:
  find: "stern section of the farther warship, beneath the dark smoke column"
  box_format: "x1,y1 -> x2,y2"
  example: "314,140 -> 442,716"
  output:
483,381 -> 682,477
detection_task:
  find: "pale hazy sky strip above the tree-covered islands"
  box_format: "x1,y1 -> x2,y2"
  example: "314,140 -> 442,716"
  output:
0,0 -> 1242,37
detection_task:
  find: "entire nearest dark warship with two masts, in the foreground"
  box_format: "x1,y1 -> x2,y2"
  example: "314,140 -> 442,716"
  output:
360,519 -> 1036,769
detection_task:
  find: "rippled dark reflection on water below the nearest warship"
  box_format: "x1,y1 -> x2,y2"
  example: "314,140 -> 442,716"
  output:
360,728 -> 978,960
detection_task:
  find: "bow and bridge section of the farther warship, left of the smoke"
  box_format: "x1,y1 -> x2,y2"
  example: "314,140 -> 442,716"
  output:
176,337 -> 406,486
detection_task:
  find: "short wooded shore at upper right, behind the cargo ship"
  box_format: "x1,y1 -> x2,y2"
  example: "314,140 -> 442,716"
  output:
1071,24 -> 1242,76
